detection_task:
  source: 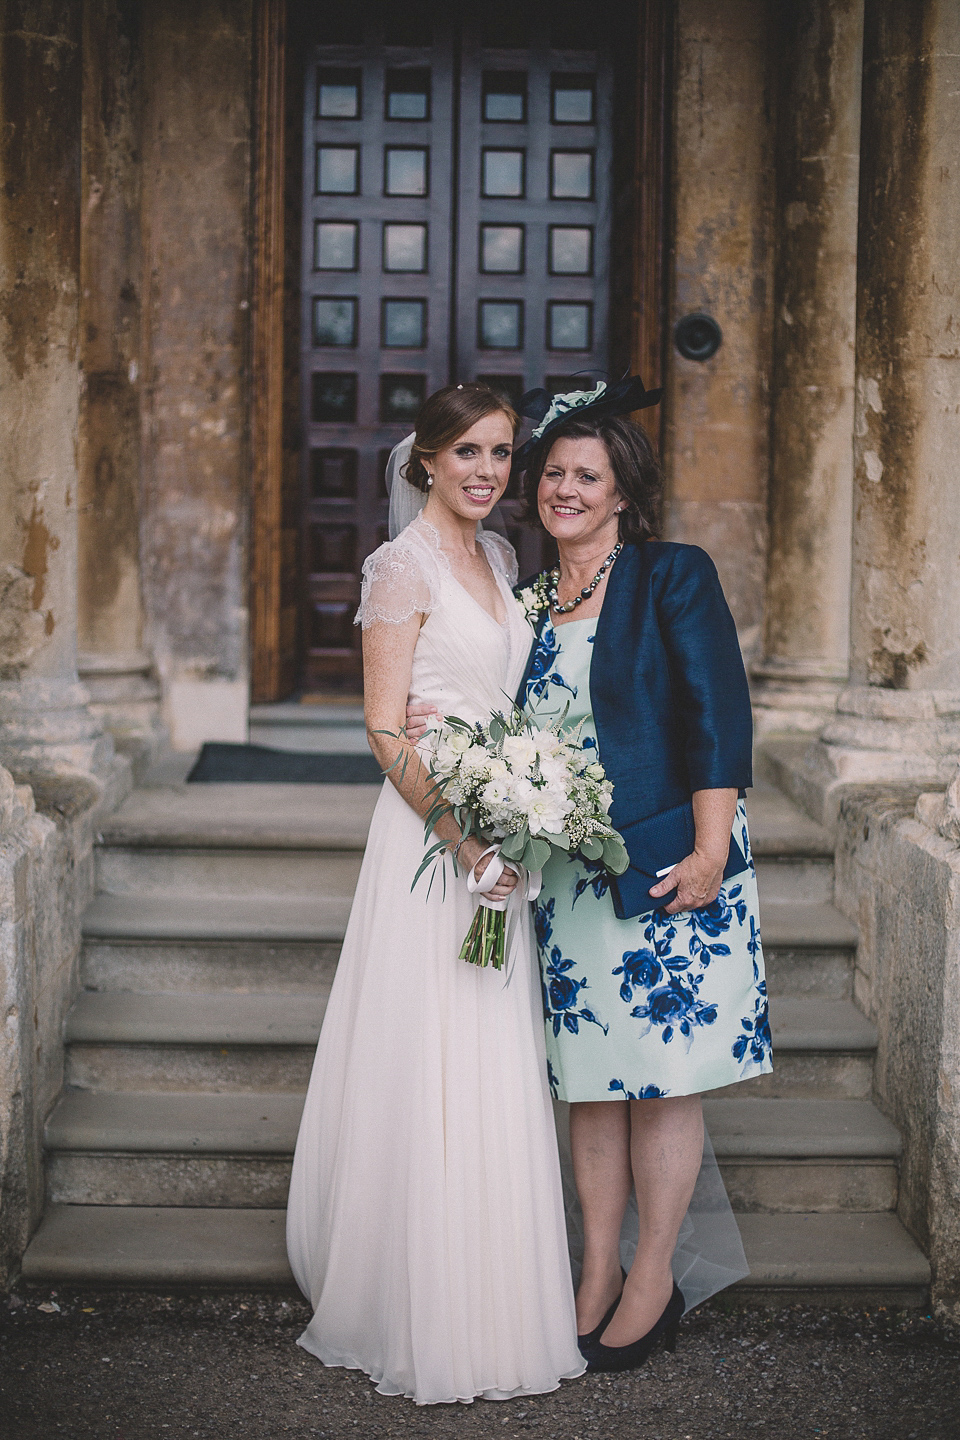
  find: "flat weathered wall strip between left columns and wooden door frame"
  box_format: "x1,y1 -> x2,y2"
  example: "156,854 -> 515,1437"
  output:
141,0 -> 252,749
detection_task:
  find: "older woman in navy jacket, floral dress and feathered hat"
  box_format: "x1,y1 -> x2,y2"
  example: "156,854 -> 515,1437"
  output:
509,384 -> 771,1369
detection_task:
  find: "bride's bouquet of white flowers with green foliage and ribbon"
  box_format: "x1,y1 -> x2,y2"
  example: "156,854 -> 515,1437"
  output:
413,706 -> 629,969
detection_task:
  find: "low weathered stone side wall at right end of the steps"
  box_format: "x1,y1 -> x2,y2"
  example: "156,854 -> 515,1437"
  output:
836,785 -> 960,1320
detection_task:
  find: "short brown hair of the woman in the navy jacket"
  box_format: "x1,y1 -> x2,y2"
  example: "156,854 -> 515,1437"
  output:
522,415 -> 664,540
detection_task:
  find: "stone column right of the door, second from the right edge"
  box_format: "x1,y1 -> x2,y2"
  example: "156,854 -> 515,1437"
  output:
753,0 -> 864,736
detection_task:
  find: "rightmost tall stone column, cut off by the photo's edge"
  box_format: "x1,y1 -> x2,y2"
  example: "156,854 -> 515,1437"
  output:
809,0 -> 960,808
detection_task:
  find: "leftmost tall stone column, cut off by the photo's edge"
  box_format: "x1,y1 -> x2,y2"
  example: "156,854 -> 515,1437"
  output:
0,0 -> 112,772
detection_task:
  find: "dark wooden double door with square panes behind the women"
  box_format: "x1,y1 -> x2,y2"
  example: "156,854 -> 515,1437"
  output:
289,0 -> 656,693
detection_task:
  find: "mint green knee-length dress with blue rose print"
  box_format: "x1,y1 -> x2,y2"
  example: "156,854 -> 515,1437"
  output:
525,616 -> 773,1102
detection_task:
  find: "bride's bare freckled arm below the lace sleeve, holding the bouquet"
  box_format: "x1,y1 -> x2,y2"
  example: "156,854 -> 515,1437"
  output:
363,615 -> 517,899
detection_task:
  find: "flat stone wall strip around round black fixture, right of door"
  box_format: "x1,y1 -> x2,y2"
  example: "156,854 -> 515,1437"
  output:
664,0 -> 773,654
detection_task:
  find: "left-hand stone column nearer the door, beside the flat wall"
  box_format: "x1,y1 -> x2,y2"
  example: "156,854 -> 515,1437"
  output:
78,0 -> 161,757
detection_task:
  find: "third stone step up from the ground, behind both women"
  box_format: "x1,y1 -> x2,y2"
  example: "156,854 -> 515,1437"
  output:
65,990 -> 877,1099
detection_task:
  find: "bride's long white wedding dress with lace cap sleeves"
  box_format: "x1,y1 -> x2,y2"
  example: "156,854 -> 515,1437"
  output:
286,517 -> 584,1404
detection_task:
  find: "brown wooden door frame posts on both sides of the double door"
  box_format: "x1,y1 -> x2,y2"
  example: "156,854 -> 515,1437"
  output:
249,0 -> 672,701
